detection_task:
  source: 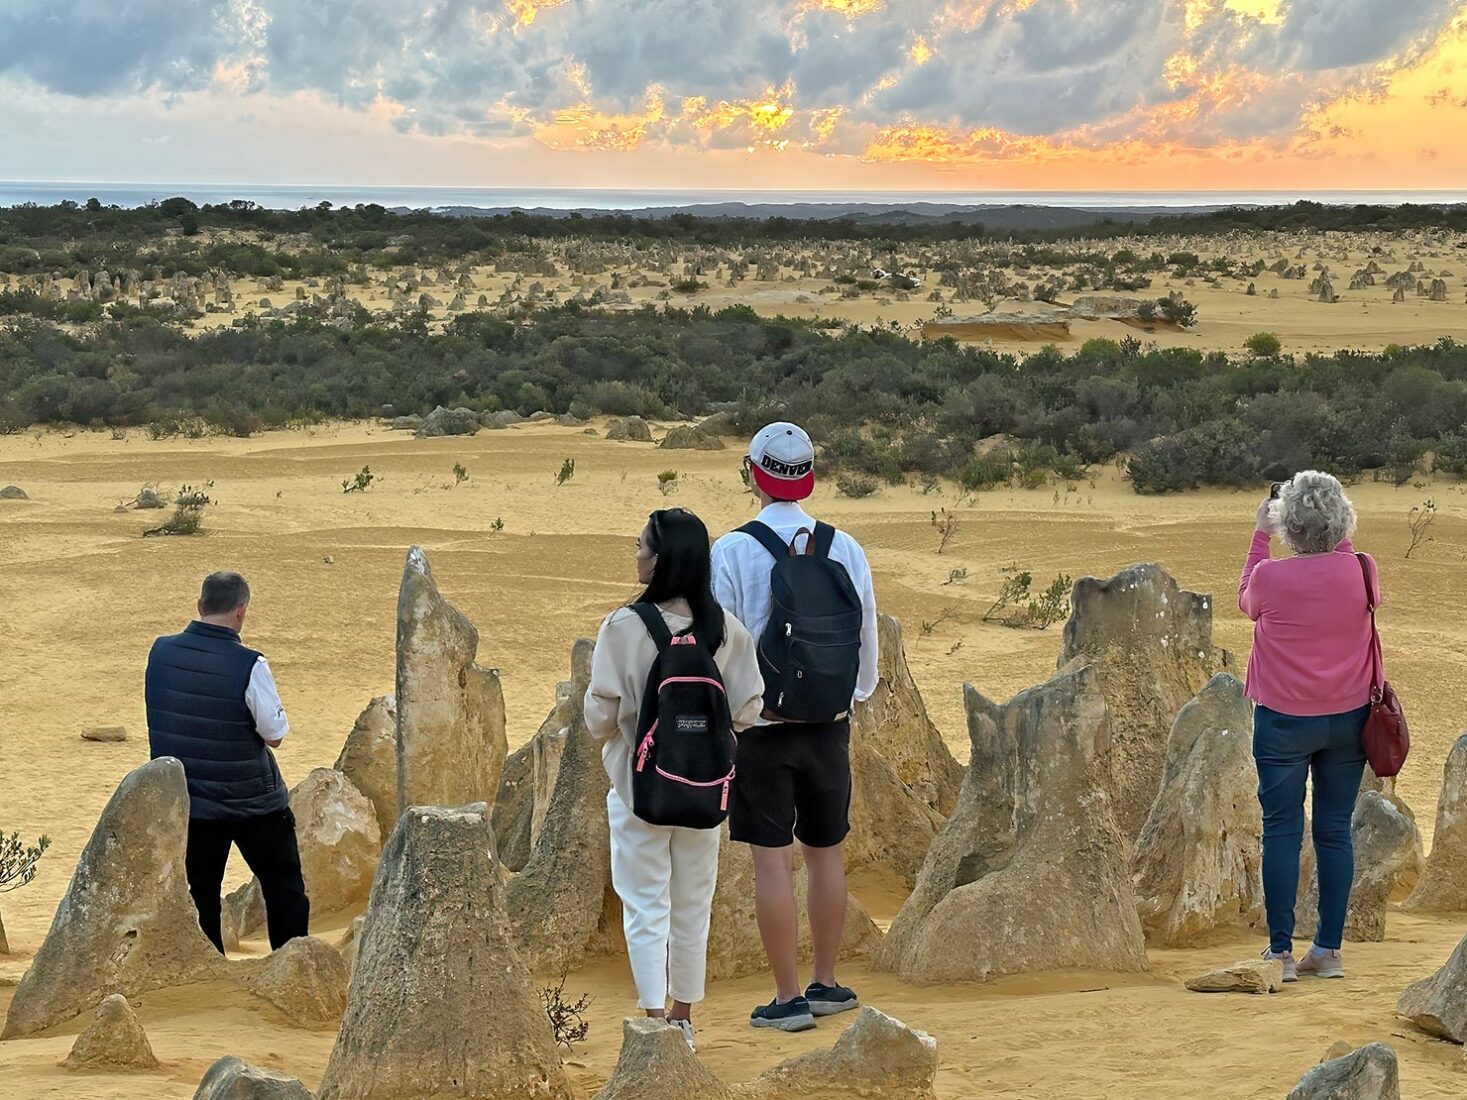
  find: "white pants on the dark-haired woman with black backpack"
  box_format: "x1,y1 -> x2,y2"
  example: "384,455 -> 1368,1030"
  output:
606,789 -> 720,1009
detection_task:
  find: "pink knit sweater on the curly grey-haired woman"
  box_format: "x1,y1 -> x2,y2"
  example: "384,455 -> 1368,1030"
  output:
1238,531 -> 1380,717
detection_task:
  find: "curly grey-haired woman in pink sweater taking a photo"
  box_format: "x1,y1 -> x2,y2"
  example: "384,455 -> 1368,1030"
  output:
1238,469 -> 1380,981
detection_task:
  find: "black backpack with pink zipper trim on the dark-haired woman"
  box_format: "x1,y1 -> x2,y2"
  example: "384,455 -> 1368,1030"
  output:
632,603 -> 738,829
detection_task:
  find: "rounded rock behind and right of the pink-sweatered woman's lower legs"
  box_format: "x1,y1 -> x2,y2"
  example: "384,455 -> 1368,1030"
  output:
1294,791 -> 1417,943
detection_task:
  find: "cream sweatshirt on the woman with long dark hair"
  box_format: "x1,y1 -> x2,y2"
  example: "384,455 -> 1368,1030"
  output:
585,607 -> 764,808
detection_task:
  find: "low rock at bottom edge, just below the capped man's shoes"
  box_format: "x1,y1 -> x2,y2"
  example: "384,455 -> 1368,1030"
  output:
733,1008 -> 937,1100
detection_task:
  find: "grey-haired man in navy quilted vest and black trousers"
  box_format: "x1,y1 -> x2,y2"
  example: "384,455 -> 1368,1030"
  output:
147,573 -> 311,953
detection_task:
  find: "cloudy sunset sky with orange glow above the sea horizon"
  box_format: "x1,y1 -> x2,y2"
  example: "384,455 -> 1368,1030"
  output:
0,0 -> 1467,189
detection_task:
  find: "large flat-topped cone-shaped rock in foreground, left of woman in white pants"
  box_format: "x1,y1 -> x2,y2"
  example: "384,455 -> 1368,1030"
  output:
321,804 -> 574,1100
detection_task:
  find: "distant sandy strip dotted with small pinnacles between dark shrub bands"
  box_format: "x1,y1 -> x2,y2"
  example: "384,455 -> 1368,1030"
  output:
20,230 -> 1467,355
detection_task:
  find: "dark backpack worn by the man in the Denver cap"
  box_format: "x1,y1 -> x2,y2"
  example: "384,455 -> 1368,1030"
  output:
739,519 -> 861,722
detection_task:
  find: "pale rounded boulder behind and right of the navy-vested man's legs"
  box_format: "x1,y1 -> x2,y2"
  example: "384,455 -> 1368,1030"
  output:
223,767 -> 381,945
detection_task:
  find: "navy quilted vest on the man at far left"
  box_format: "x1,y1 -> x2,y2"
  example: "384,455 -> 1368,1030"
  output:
147,622 -> 290,820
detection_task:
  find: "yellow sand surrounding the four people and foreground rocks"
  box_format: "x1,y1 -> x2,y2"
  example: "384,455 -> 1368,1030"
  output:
0,416 -> 1467,1100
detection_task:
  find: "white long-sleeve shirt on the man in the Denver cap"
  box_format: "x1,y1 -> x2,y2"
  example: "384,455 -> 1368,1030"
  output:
713,500 -> 880,725
